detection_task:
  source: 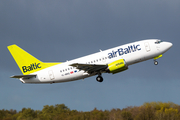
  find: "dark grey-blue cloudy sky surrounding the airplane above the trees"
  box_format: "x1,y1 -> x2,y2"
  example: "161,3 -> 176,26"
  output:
0,0 -> 180,111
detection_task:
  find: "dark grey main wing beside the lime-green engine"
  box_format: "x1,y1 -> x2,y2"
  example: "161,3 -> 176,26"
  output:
70,63 -> 108,74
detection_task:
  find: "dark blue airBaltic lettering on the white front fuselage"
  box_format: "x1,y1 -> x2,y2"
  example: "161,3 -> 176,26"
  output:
108,44 -> 141,59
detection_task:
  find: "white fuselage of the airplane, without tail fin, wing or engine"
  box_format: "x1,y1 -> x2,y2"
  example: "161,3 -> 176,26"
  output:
20,39 -> 172,83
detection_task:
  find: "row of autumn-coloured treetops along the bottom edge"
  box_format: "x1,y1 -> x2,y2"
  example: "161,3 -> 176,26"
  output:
0,102 -> 180,120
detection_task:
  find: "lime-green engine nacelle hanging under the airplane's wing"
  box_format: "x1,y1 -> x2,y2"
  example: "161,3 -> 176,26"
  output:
108,59 -> 128,74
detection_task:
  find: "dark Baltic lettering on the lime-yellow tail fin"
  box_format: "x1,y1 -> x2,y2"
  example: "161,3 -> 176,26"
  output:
22,63 -> 41,73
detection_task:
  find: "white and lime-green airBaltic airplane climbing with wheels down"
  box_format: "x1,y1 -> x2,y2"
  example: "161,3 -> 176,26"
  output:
7,39 -> 173,84
